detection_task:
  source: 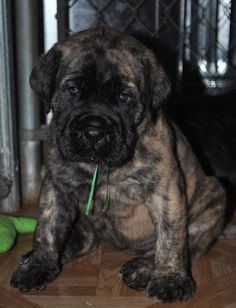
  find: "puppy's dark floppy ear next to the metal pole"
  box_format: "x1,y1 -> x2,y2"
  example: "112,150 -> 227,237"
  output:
30,47 -> 62,112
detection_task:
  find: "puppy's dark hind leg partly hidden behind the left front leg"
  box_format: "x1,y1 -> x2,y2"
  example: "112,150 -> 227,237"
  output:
61,218 -> 99,264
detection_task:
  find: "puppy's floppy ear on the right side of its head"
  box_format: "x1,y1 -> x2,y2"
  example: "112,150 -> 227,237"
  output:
145,50 -> 171,122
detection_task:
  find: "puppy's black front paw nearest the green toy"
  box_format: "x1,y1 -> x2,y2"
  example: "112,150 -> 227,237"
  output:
10,252 -> 60,292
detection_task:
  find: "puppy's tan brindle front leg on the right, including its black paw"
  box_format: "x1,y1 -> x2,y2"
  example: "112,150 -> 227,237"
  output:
147,179 -> 195,302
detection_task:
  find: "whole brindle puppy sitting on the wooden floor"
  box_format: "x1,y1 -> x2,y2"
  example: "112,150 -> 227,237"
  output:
11,28 -> 225,302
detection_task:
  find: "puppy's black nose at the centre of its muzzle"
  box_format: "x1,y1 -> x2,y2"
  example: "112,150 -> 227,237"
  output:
83,116 -> 106,140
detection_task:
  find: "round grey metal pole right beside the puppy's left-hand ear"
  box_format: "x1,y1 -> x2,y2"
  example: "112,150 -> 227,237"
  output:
15,0 -> 41,202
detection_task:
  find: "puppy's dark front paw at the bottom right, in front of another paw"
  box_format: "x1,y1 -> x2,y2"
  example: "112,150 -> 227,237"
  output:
147,274 -> 196,303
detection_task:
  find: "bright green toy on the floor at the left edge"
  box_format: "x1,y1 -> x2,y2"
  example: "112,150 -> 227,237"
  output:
0,215 -> 37,253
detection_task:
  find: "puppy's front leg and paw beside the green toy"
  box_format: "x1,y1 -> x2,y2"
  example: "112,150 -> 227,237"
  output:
11,179 -> 75,292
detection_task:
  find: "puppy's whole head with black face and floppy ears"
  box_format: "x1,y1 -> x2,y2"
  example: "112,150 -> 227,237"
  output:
30,28 -> 169,166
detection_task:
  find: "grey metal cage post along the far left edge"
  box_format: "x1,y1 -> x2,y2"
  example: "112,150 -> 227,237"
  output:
0,0 -> 20,212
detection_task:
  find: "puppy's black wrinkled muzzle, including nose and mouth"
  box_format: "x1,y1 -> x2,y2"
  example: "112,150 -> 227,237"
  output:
57,114 -> 134,166
